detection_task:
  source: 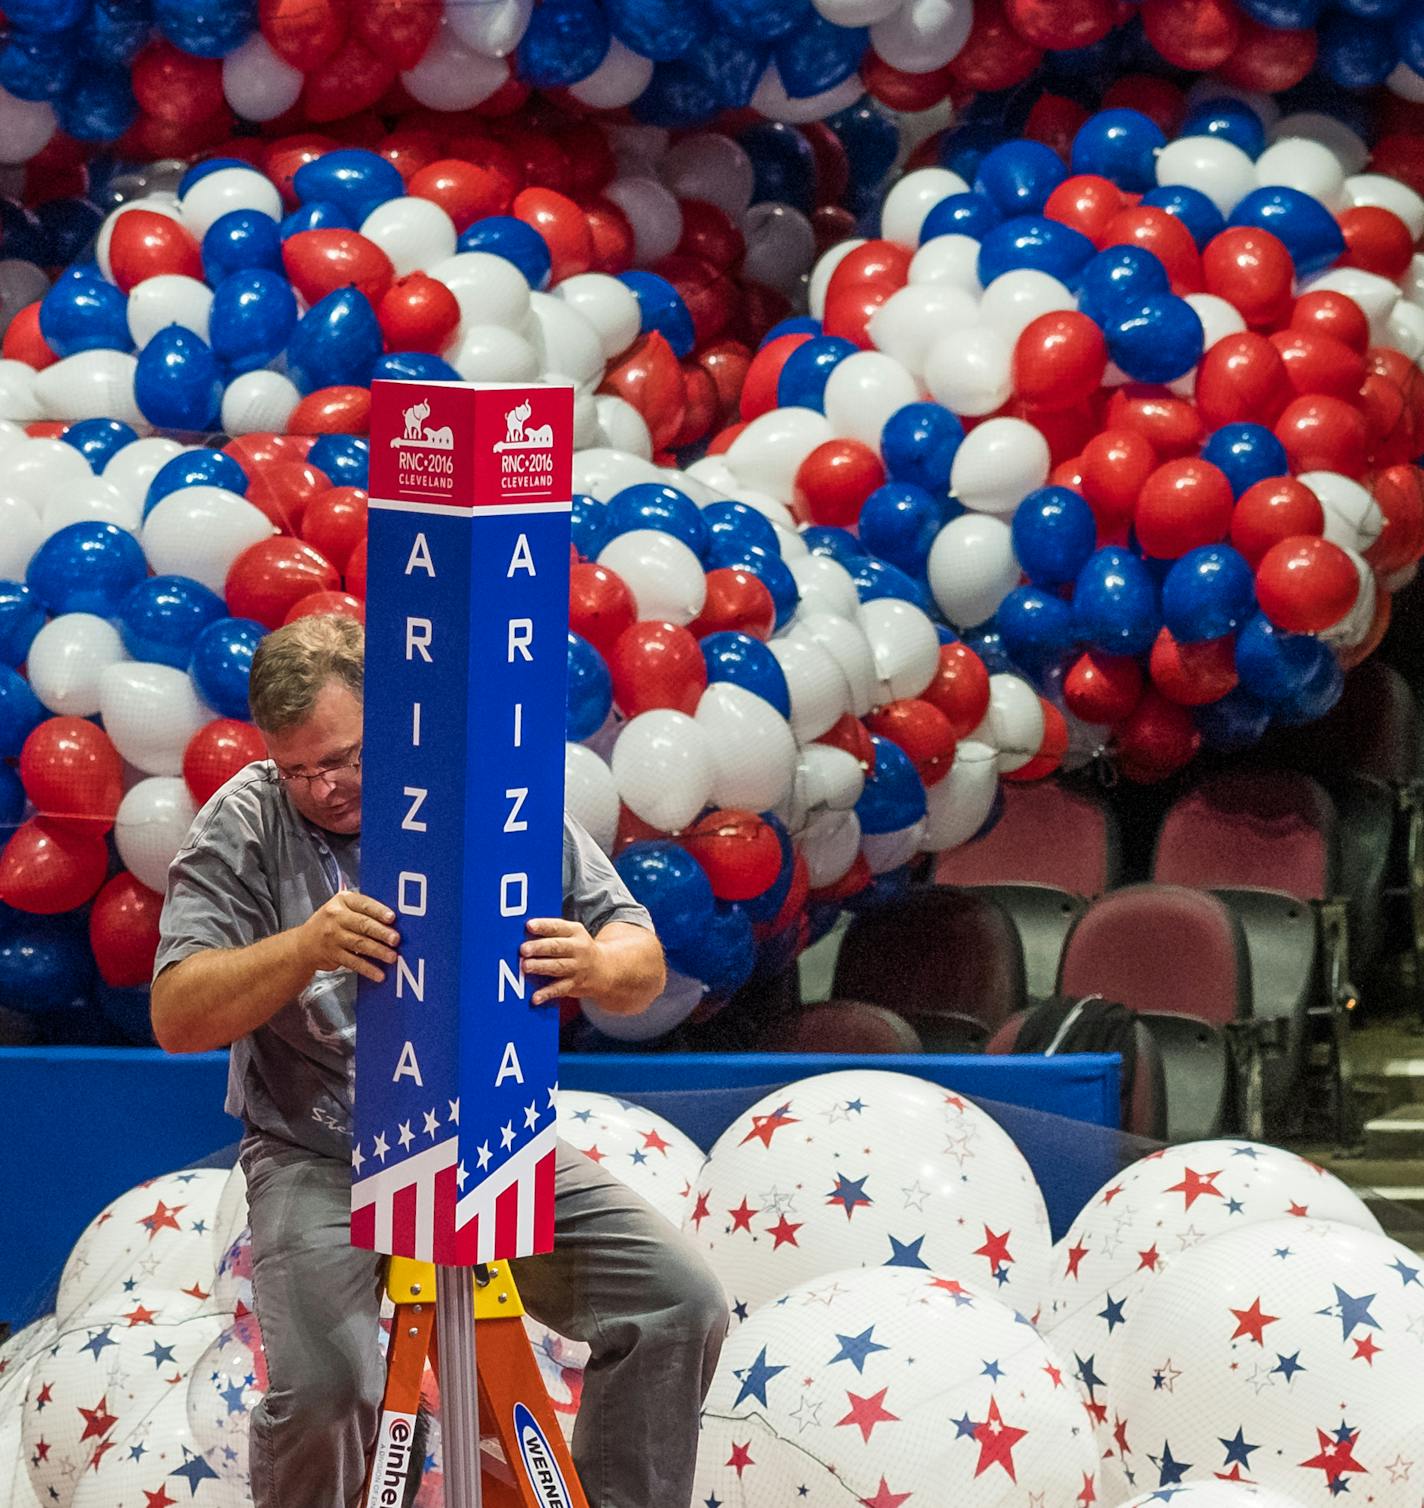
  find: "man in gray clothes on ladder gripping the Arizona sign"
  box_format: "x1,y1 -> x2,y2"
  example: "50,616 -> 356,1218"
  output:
152,617 -> 727,1508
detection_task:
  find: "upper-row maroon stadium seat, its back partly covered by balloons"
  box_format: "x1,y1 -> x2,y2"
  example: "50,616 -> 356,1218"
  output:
935,780 -> 1119,998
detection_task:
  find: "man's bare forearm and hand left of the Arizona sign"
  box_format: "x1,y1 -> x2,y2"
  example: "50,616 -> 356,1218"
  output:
149,890 -> 400,1053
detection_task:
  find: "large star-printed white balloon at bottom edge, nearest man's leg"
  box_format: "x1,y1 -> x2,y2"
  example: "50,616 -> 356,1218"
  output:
692,1267 -> 1100,1508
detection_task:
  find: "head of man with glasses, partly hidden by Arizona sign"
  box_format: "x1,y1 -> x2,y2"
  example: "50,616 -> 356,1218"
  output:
247,612 -> 367,832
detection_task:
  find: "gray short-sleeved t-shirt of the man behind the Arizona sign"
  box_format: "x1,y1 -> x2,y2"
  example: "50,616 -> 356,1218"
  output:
154,760 -> 653,1158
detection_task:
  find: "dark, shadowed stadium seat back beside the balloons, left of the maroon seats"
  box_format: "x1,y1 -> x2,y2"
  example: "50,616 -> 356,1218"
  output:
833,885 -> 1026,1053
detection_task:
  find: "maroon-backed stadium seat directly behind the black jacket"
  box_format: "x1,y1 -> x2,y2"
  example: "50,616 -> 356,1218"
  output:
1057,885 -> 1251,1142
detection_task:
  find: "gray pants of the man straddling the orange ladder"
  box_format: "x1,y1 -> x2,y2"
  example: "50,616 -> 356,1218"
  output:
241,1133 -> 727,1508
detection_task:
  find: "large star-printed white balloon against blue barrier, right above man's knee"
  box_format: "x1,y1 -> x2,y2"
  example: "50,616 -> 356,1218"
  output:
683,1069 -> 1050,1320
